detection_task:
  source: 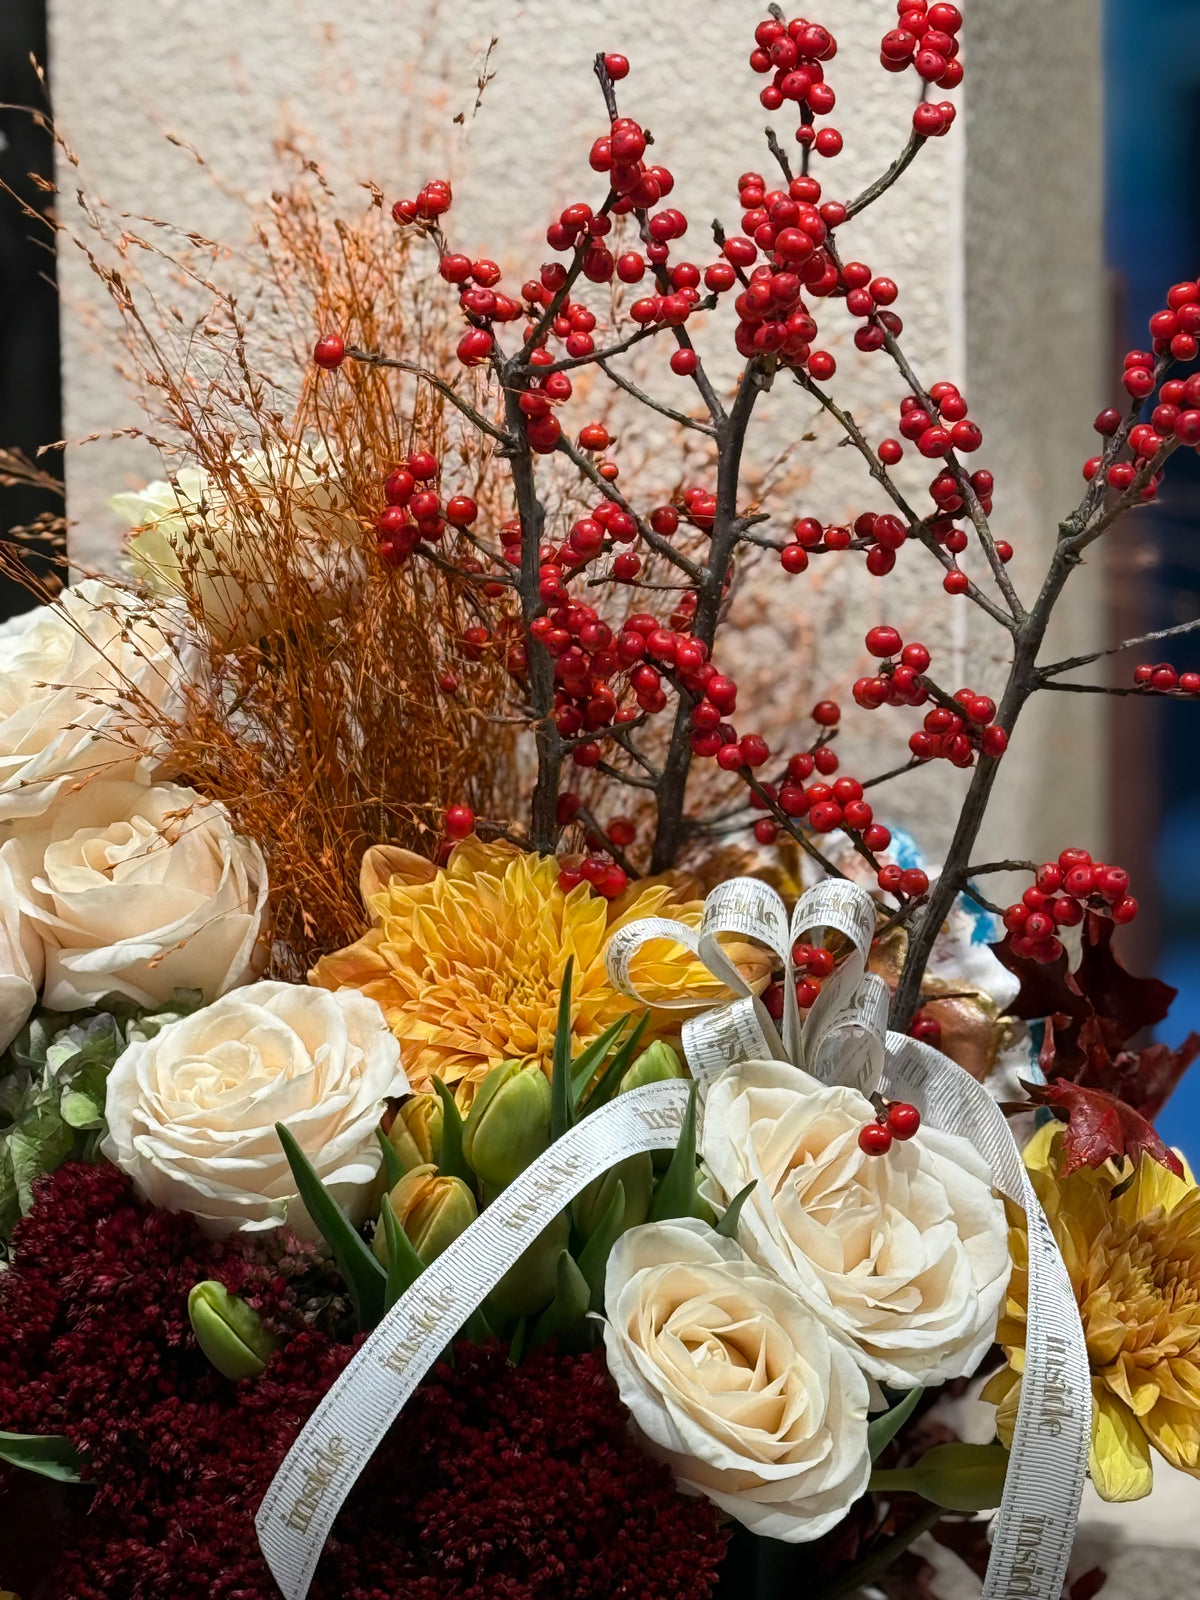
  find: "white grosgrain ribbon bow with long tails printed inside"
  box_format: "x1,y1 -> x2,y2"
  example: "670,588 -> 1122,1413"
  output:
256,878 -> 1091,1600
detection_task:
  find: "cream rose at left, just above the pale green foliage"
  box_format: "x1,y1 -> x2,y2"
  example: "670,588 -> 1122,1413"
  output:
0,779 -> 267,1027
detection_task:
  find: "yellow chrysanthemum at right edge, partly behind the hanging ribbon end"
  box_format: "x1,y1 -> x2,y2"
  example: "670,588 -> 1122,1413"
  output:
984,1123 -> 1200,1501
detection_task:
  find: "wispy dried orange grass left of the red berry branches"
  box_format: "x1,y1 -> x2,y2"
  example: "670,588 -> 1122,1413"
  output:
42,150 -> 515,979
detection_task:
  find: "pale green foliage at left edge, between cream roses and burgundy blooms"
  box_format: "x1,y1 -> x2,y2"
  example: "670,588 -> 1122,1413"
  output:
0,989 -> 203,1245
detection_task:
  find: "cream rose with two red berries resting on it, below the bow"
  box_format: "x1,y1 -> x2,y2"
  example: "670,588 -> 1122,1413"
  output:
702,1061 -> 1010,1387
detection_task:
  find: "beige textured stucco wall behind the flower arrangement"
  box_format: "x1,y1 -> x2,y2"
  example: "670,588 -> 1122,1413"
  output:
51,0 -> 1102,854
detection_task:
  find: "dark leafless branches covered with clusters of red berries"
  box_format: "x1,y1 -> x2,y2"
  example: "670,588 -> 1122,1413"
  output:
314,0 -> 1200,1030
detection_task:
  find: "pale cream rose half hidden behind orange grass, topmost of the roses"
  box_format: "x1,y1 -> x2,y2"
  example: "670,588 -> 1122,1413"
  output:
109,445 -> 362,645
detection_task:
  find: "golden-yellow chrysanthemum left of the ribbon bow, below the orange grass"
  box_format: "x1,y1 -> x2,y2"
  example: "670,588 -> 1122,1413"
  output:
309,838 -> 765,1102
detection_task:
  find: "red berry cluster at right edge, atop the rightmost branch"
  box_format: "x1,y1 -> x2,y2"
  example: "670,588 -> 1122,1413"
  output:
1083,282 -> 1200,501
